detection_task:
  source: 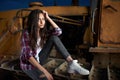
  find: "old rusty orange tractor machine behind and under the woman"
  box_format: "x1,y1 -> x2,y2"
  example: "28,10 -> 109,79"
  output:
0,0 -> 120,80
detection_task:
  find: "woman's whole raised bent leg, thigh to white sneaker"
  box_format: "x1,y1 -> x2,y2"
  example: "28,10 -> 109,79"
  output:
40,36 -> 89,75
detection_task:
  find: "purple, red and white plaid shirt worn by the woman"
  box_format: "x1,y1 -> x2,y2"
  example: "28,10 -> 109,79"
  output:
20,28 -> 62,70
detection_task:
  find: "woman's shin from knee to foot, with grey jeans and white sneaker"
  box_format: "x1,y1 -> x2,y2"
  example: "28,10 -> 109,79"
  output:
47,36 -> 89,75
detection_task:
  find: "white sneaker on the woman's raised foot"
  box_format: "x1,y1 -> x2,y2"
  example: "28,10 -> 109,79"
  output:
68,60 -> 89,75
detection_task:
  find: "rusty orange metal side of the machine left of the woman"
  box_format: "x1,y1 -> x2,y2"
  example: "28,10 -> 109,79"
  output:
0,18 -> 22,57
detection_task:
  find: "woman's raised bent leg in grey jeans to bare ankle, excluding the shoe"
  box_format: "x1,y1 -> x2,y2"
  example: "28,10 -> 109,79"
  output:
39,36 -> 73,64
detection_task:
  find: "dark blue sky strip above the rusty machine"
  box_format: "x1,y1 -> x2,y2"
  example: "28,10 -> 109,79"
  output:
0,0 -> 90,11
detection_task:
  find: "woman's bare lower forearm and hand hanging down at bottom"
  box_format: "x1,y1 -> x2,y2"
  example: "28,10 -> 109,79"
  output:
29,57 -> 53,80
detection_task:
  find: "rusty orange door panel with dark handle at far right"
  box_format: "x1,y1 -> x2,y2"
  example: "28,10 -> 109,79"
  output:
98,0 -> 120,47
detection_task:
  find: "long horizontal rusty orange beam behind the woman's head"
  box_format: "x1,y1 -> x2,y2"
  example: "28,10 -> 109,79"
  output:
0,6 -> 88,18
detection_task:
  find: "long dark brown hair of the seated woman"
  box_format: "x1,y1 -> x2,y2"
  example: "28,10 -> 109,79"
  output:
27,9 -> 47,49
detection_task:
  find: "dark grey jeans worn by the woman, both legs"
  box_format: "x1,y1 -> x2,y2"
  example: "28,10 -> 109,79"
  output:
24,36 -> 70,80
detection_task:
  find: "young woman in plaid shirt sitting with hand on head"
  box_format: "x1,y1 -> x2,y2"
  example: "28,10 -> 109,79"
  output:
20,9 -> 89,80
